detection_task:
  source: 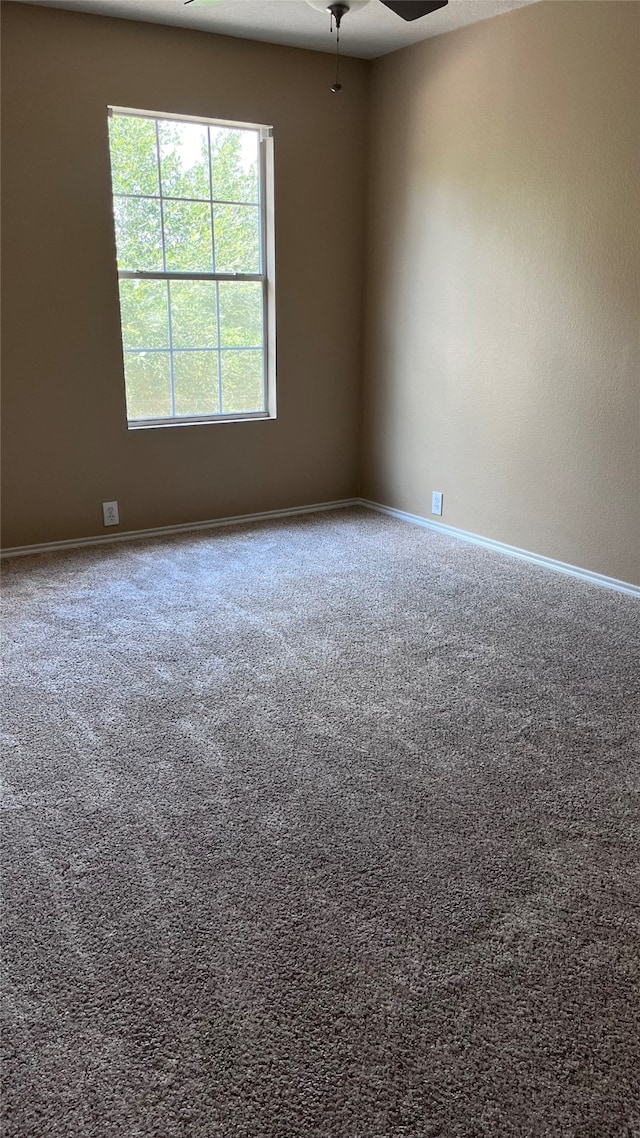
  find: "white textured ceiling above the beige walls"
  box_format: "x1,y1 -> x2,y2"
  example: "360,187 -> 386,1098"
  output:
18,0 -> 536,59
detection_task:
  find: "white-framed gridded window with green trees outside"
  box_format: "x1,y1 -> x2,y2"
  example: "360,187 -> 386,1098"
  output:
109,107 -> 276,427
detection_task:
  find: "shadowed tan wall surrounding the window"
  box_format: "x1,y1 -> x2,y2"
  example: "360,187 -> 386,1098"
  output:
2,3 -> 367,546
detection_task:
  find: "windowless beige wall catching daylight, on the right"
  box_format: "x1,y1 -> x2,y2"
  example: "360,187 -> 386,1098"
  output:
362,0 -> 640,584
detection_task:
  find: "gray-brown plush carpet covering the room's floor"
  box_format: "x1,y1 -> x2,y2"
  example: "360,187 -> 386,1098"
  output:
2,510 -> 640,1138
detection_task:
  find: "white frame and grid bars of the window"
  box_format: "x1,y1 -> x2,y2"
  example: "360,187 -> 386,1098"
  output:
107,105 -> 277,430
